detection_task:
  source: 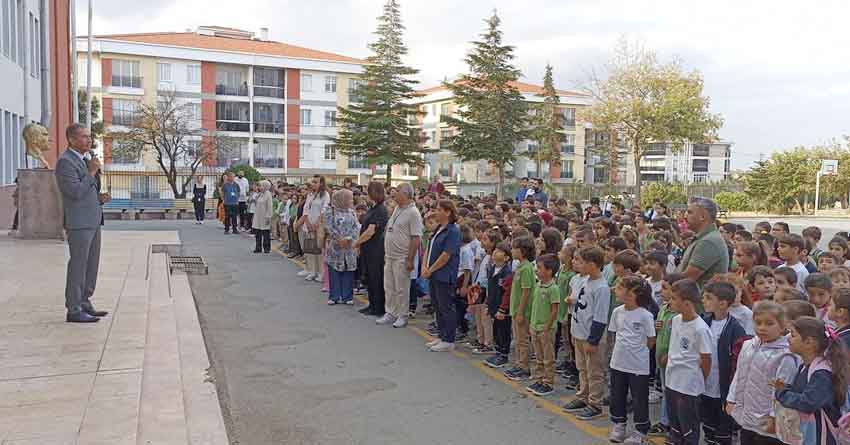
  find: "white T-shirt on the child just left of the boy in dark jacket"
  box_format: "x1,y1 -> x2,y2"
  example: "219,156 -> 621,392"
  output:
664,314 -> 715,397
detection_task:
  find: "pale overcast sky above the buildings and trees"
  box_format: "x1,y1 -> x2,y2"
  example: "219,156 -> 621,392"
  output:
76,0 -> 850,168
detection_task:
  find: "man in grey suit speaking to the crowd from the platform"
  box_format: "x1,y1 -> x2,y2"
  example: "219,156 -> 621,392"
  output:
56,124 -> 107,323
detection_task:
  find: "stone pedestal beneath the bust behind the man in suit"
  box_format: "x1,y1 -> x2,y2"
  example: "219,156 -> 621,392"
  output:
18,169 -> 65,240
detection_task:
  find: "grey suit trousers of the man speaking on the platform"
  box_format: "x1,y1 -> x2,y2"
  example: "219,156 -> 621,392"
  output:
65,227 -> 100,314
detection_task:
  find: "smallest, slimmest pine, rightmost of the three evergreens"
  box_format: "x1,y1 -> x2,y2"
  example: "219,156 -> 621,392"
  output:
531,64 -> 564,178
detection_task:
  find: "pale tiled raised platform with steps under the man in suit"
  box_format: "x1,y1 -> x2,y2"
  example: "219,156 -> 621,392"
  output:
0,231 -> 228,445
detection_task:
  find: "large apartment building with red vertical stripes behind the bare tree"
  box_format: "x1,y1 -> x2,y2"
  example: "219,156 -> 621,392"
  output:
77,26 -> 368,174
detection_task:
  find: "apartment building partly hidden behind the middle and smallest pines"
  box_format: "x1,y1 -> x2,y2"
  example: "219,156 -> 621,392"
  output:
414,82 -> 590,183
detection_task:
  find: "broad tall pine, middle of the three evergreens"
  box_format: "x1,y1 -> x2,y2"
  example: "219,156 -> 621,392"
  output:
443,12 -> 528,196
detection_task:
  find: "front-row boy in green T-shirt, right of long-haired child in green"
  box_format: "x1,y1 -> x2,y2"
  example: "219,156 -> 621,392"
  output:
526,254 -> 561,396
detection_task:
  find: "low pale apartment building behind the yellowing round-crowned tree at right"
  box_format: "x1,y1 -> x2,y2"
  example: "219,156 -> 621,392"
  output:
585,128 -> 732,185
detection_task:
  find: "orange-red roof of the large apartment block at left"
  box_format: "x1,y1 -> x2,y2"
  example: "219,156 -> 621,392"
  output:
95,28 -> 366,64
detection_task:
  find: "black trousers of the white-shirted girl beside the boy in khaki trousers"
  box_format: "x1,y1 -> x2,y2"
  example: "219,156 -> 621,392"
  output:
609,368 -> 649,434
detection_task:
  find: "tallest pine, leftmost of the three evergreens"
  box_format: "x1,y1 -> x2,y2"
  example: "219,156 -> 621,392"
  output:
335,0 -> 430,182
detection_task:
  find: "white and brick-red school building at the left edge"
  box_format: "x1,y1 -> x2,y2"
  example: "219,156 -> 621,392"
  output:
0,0 -> 72,228
